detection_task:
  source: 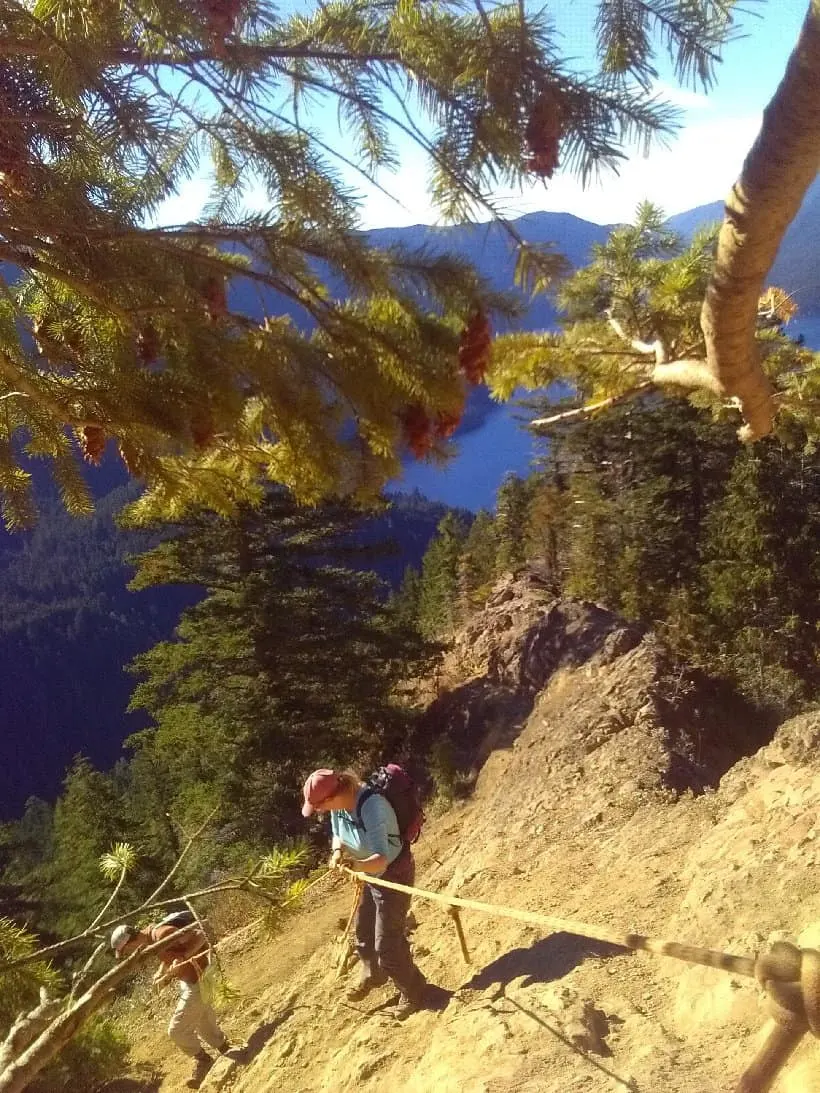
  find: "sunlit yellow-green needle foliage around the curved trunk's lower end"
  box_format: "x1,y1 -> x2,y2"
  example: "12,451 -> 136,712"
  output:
488,201 -> 820,444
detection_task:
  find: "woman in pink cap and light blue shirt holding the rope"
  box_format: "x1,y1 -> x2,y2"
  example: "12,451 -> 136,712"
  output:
302,768 -> 426,1021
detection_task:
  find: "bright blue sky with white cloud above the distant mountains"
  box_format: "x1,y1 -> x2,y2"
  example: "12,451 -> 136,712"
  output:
162,0 -> 808,227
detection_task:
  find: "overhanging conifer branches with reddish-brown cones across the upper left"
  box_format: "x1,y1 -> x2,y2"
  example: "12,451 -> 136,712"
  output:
0,0 -> 734,526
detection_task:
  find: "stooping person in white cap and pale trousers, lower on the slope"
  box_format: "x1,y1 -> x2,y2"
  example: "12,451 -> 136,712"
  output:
110,912 -> 231,1090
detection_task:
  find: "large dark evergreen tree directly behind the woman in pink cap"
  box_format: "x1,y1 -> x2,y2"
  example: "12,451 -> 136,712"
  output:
131,492 -> 433,842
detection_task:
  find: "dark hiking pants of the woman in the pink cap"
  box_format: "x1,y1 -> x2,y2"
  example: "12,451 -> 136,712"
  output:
355,853 -> 424,1001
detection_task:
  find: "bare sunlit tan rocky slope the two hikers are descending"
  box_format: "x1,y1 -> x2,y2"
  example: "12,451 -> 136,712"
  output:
110,578 -> 820,1093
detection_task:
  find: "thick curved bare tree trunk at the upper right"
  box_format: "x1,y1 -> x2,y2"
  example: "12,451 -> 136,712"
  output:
701,0 -> 820,439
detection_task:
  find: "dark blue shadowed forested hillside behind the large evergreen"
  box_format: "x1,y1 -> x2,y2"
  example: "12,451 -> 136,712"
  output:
0,487 -> 459,819
